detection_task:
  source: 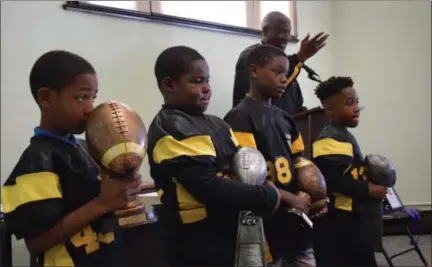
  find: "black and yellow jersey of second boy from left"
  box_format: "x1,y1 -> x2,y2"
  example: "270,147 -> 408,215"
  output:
148,105 -> 279,266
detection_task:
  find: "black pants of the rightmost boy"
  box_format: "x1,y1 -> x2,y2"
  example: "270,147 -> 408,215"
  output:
314,209 -> 377,266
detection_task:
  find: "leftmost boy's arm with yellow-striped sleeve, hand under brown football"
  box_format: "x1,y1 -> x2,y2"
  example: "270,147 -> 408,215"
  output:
1,170 -> 137,252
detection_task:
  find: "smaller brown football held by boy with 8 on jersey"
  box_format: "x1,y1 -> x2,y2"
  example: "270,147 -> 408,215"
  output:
294,157 -> 327,207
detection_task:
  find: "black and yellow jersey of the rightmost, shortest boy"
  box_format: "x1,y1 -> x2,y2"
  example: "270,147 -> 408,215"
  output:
312,123 -> 368,212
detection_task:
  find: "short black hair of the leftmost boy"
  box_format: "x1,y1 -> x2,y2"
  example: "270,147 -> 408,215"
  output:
30,50 -> 96,102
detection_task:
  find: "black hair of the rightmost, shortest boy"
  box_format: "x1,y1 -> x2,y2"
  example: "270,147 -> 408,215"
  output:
315,76 -> 354,102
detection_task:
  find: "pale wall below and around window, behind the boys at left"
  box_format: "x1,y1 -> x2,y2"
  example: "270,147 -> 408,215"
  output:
1,1 -> 332,266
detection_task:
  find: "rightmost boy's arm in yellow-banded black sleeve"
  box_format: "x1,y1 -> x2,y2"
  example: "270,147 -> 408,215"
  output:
313,138 -> 369,198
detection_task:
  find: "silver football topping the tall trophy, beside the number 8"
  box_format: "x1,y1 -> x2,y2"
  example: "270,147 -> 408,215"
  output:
231,147 -> 267,185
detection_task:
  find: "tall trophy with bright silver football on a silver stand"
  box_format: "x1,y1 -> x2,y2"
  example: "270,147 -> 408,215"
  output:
232,147 -> 267,267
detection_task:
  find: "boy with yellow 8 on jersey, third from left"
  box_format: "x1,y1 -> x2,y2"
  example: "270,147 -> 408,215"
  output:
224,45 -> 315,266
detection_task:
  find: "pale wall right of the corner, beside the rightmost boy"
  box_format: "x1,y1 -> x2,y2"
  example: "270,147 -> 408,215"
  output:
331,1 -> 431,209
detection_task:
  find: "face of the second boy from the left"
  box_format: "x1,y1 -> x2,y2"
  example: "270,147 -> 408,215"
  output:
163,60 -> 212,112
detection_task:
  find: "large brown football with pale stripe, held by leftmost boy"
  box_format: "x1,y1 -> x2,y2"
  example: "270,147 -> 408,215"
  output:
85,101 -> 147,176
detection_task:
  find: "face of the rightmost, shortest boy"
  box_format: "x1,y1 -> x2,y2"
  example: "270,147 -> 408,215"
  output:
326,87 -> 360,128
